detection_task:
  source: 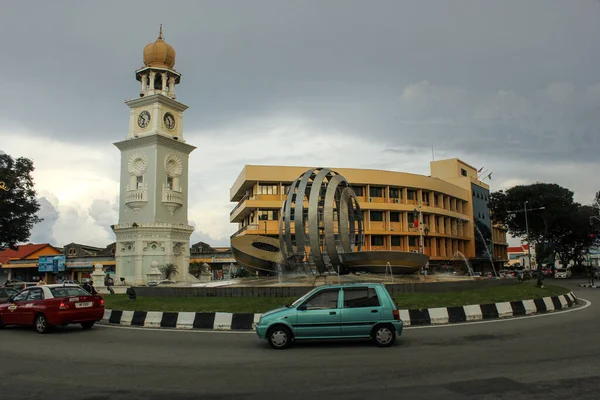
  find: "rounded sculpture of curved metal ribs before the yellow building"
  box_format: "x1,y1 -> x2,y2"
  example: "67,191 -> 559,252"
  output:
279,168 -> 364,273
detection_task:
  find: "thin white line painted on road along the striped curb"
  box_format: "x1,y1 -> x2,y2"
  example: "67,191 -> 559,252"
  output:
96,297 -> 592,335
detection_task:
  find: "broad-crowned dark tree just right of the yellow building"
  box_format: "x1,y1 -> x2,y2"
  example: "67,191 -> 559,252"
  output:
489,183 -> 577,287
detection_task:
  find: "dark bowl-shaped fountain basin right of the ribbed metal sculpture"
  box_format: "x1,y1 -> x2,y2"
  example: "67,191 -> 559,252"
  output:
341,250 -> 429,274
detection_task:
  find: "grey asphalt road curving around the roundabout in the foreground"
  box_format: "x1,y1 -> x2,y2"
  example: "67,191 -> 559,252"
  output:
0,282 -> 600,400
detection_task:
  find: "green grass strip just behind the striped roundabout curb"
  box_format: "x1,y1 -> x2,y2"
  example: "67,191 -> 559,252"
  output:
104,283 -> 570,313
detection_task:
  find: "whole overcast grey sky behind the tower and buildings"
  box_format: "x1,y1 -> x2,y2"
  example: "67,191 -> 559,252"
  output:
0,0 -> 600,246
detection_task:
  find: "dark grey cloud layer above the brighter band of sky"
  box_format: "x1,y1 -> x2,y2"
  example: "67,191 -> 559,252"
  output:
0,0 -> 600,160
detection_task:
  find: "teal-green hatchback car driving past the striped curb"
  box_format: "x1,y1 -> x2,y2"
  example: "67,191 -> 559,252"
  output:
256,283 -> 402,349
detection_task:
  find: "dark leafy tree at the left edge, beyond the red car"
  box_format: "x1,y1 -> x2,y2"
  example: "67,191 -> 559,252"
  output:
0,154 -> 42,249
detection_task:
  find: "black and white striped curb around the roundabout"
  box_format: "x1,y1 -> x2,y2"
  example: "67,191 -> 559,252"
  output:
102,292 -> 578,331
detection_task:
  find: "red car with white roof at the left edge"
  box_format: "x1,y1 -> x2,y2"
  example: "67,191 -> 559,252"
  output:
0,285 -> 104,333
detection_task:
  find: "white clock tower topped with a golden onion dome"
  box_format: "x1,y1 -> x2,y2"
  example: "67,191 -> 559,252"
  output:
113,26 -> 195,285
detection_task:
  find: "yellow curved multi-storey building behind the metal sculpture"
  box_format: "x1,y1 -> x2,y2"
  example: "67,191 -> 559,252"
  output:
230,158 -> 508,270
